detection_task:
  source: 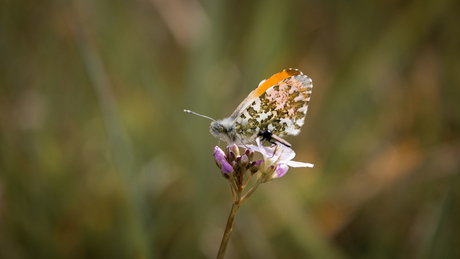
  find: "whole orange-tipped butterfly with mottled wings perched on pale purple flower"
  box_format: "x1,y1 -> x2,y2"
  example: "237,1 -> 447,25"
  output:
184,68 -> 313,146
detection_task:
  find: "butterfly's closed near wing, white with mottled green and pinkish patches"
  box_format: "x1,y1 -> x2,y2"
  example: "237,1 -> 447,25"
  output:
232,69 -> 313,141
